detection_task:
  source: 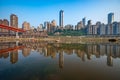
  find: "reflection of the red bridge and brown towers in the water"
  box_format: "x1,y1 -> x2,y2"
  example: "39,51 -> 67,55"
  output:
0,42 -> 24,64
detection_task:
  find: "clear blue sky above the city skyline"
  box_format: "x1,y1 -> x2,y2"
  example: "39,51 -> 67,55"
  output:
0,0 -> 120,27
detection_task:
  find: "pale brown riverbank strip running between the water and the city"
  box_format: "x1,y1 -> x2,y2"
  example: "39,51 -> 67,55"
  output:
0,36 -> 120,43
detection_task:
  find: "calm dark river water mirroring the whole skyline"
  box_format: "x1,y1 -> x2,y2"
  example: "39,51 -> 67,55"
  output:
0,42 -> 120,80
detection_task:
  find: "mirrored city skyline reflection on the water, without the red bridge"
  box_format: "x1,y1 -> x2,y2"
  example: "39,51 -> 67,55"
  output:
0,42 -> 120,68
